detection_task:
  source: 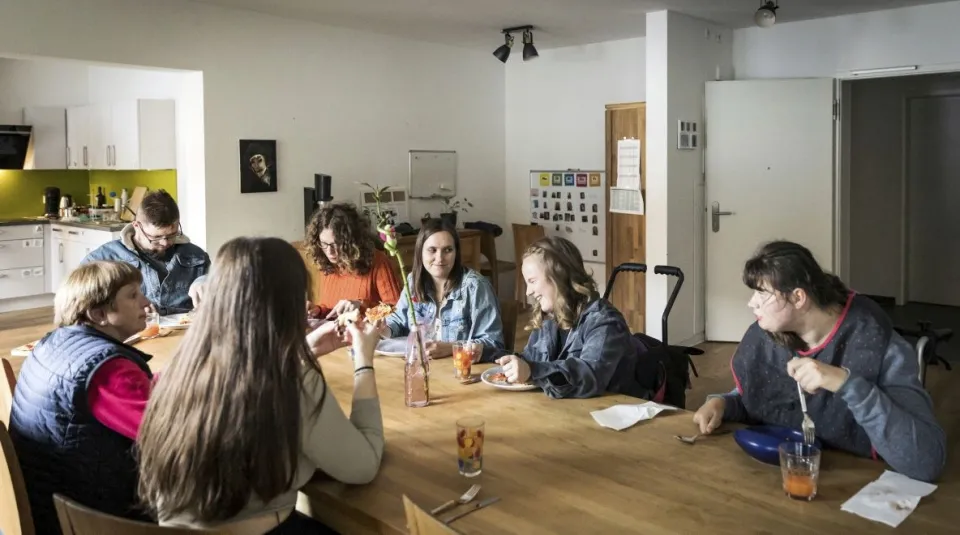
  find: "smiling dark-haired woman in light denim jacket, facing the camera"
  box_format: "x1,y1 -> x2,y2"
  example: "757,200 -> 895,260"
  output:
384,219 -> 504,358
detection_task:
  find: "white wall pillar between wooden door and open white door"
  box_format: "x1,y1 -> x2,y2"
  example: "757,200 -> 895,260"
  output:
646,11 -> 733,344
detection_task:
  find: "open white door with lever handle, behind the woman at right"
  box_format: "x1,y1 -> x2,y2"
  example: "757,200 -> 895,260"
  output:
704,79 -> 835,342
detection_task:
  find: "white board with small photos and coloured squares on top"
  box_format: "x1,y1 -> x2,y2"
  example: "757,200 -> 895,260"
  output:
530,170 -> 607,263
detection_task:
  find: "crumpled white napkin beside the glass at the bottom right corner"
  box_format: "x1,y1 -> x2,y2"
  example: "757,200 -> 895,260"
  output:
840,470 -> 937,528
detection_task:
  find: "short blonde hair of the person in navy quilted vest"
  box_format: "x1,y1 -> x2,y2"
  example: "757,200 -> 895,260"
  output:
53,261 -> 143,327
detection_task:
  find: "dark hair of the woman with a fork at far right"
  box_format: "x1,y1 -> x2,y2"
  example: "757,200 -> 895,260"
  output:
743,241 -> 850,351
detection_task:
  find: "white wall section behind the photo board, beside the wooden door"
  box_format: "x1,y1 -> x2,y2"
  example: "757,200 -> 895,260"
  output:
497,38 -> 645,292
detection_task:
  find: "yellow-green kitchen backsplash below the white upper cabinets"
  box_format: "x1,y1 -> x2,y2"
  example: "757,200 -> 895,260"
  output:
0,169 -> 177,219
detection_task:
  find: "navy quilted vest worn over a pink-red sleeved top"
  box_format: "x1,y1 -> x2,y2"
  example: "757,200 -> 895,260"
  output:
10,326 -> 152,534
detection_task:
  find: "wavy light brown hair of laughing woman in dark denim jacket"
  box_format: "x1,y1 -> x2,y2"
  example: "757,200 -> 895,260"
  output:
523,236 -> 600,330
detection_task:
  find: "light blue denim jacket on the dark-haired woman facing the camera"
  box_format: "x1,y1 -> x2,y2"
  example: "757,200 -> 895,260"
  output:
387,268 -> 504,353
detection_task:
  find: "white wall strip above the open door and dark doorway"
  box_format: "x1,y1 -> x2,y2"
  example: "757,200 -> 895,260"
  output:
733,2 -> 960,79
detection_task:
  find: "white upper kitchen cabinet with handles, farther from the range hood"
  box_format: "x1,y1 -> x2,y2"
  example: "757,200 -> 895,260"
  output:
67,100 -> 177,170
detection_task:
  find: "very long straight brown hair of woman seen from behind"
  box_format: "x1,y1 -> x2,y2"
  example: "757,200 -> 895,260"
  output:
137,238 -> 322,522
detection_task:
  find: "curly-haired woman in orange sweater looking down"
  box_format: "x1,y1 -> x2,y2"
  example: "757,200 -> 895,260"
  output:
306,203 -> 400,319
